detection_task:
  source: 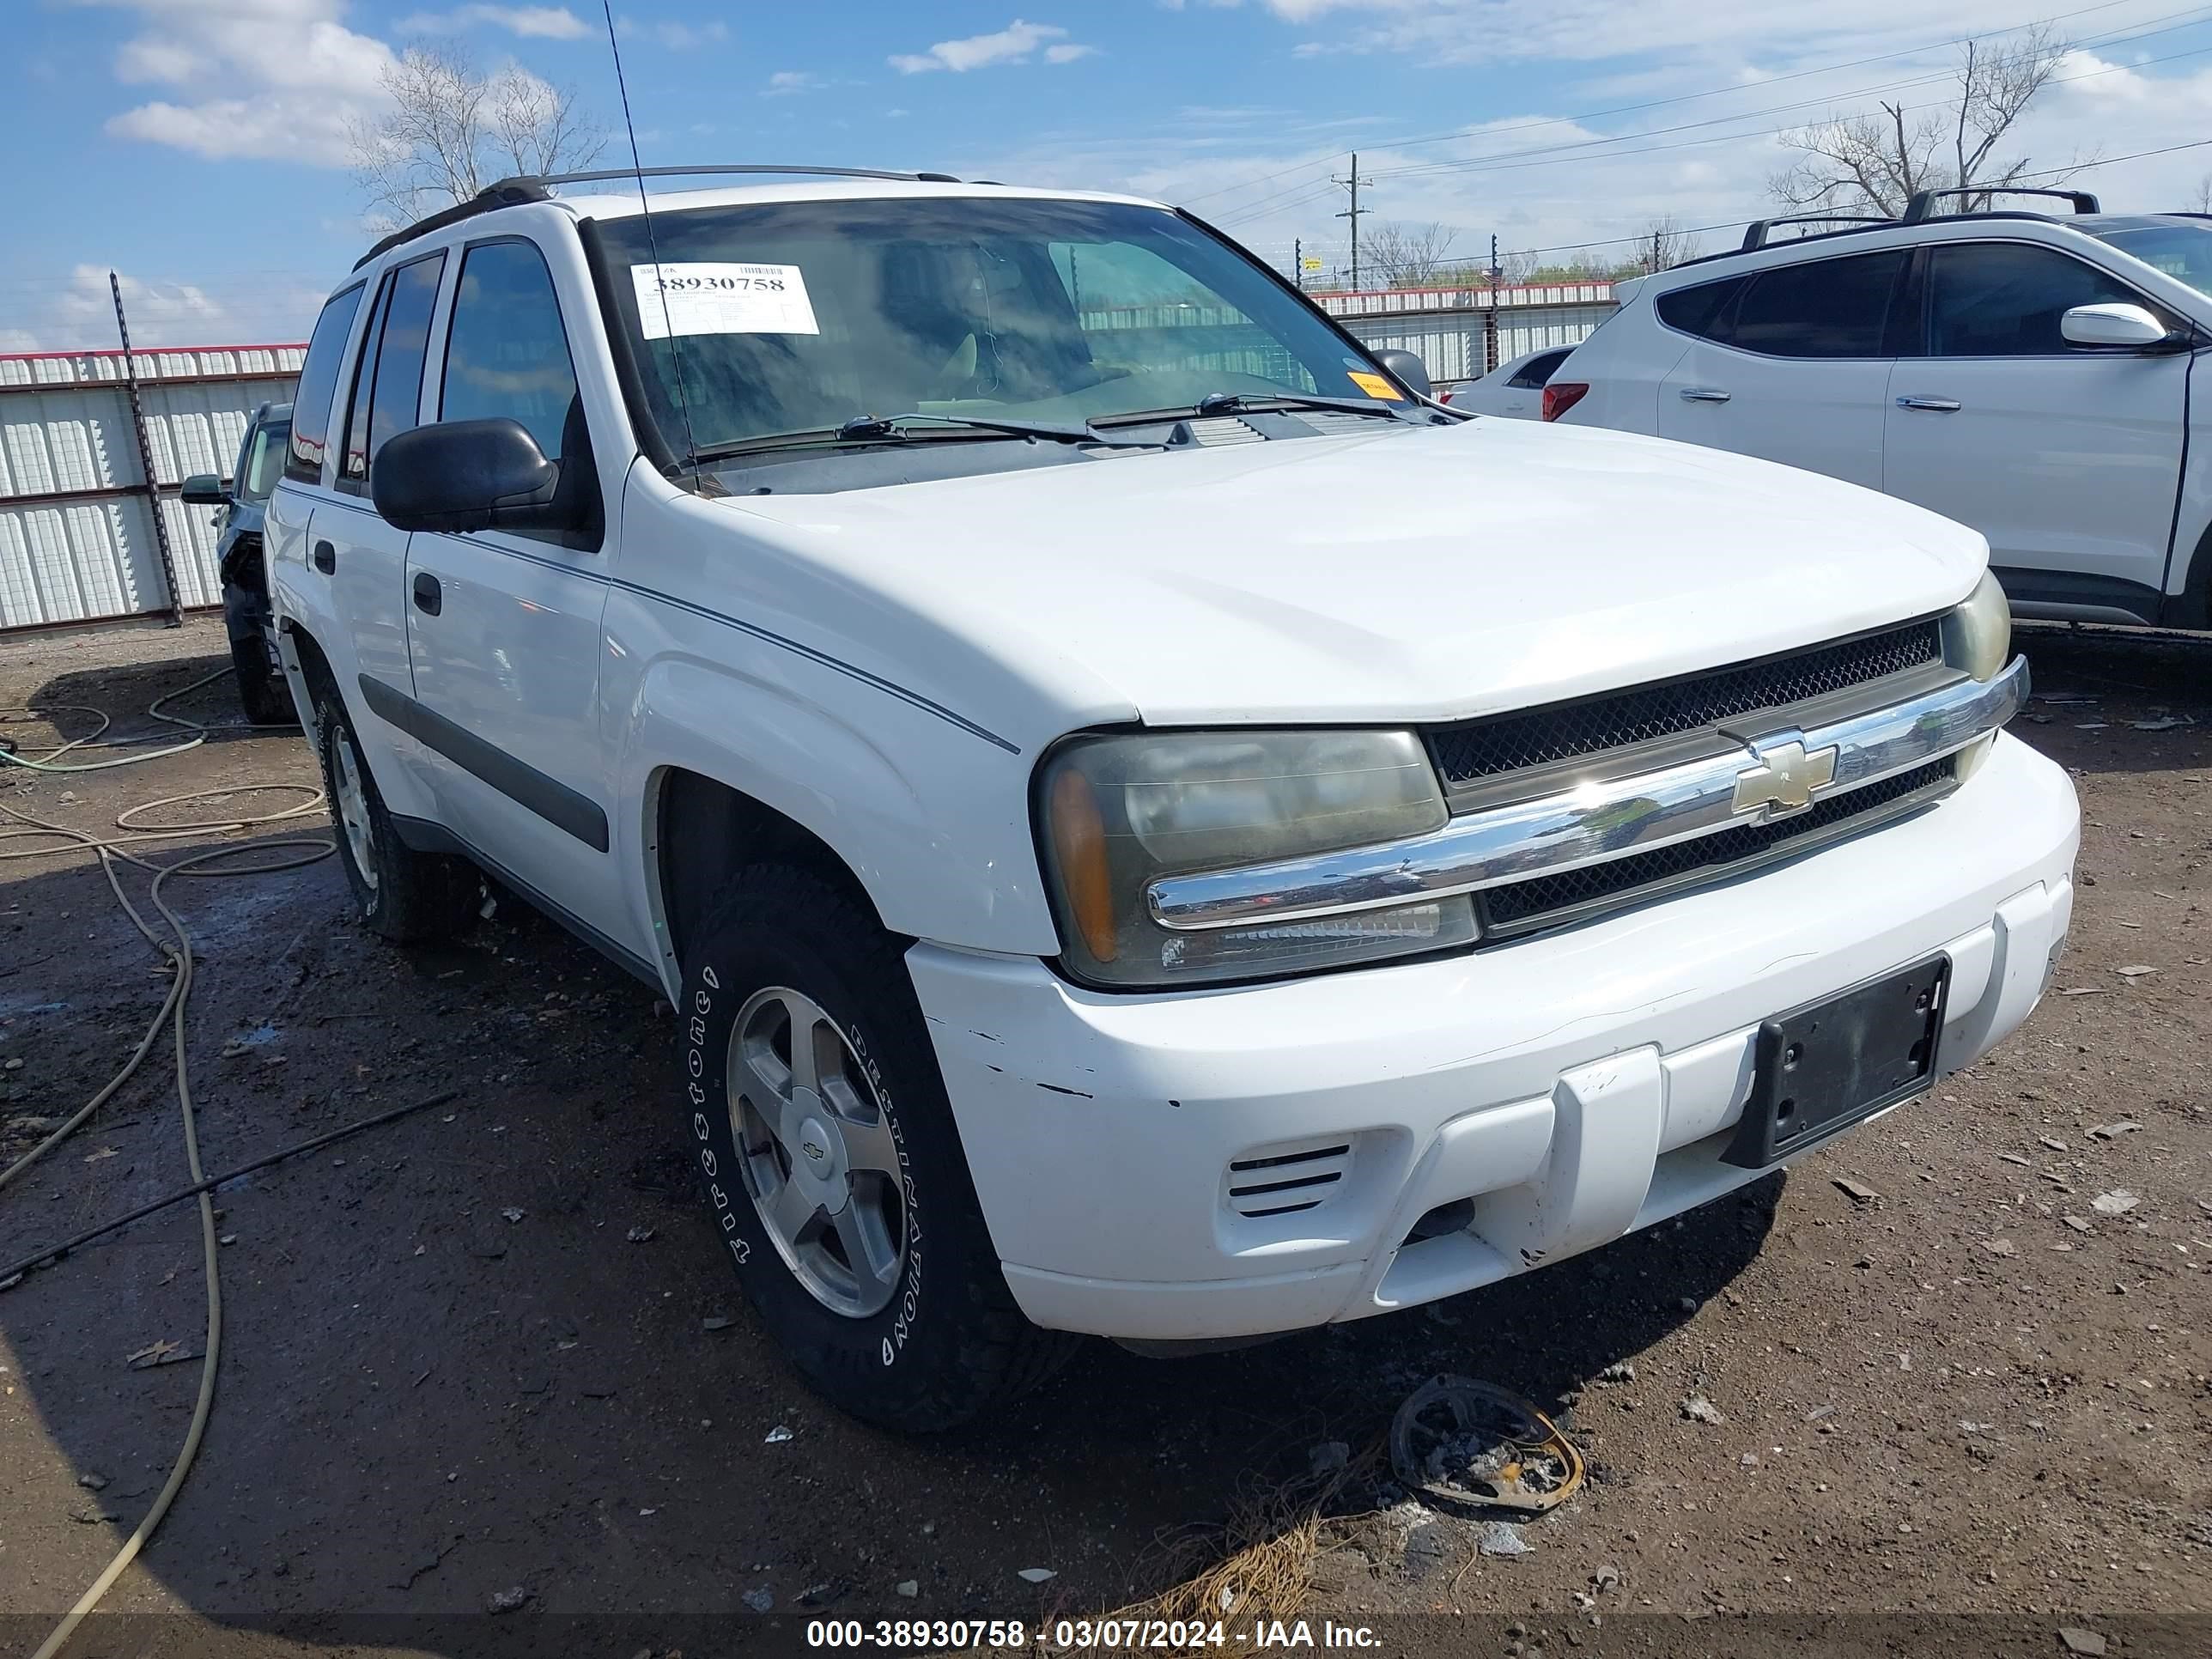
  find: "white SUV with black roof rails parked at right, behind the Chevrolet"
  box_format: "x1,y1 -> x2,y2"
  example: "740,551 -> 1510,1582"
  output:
1547,191 -> 2212,629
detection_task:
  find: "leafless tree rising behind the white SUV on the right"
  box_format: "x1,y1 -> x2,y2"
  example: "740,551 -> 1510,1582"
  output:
1767,24 -> 2088,219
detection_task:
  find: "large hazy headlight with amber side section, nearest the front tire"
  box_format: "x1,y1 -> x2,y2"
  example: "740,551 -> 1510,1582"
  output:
1037,732 -> 1475,987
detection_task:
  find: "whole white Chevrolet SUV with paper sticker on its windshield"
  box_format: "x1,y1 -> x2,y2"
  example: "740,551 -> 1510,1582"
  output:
268,168 -> 2077,1429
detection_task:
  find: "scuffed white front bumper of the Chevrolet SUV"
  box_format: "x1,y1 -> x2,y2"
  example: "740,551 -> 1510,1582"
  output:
907,737 -> 2079,1340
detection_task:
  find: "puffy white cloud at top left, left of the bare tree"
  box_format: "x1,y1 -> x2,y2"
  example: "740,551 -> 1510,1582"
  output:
77,0 -> 392,166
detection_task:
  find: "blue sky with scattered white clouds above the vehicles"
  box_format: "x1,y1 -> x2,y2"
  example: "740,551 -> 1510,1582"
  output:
13,0 -> 2212,352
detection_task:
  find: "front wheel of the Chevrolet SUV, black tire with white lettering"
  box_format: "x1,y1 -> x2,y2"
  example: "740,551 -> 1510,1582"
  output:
677,865 -> 1082,1433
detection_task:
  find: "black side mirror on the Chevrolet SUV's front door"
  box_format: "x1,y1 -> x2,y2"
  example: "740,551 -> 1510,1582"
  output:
369,416 -> 573,531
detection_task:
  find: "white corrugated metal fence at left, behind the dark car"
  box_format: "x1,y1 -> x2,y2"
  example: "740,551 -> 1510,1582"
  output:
0,345 -> 305,629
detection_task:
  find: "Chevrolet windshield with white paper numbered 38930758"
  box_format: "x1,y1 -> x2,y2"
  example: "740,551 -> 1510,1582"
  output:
602,197 -> 1402,456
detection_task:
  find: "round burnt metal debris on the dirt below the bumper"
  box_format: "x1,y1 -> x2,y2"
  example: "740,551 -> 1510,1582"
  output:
1389,1376 -> 1583,1516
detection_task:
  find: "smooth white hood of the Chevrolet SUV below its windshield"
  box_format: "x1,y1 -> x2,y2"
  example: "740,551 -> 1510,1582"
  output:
723,420 -> 1989,726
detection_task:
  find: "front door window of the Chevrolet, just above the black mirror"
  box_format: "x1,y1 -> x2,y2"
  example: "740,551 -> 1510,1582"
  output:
438,241 -> 575,460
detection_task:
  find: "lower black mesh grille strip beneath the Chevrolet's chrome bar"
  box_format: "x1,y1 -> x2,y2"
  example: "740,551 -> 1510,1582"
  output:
1475,757 -> 1958,936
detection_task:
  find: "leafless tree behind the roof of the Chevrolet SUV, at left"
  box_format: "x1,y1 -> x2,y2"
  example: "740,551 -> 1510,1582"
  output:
347,46 -> 606,226
